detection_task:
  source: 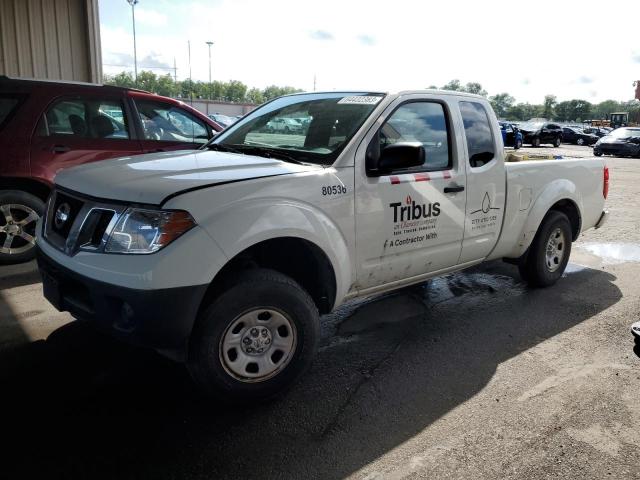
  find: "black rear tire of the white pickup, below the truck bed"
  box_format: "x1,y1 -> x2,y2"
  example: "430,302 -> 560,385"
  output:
518,210 -> 572,287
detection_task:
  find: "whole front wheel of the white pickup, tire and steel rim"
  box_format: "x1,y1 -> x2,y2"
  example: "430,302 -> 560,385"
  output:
188,269 -> 320,403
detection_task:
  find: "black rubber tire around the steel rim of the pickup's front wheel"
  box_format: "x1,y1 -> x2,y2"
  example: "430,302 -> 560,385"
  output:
187,269 -> 320,403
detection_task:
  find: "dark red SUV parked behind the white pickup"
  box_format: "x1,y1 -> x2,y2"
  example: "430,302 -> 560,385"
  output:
0,76 -> 222,264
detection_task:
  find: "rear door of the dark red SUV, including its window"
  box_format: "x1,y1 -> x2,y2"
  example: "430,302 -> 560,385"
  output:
30,94 -> 142,182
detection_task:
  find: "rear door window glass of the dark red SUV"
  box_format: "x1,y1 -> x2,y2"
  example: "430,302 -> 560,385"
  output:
37,98 -> 129,139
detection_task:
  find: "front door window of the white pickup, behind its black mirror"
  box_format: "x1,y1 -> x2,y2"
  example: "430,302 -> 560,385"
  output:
379,102 -> 451,171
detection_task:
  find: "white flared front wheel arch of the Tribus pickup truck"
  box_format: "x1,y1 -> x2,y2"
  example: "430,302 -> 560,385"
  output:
201,198 -> 352,304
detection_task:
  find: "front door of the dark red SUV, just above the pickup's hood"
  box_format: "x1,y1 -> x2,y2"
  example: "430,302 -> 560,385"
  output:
133,96 -> 213,152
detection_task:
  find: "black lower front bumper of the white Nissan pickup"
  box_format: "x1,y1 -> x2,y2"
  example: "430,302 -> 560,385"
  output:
38,248 -> 208,361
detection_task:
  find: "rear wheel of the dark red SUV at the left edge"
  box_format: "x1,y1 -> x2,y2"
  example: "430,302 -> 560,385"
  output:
0,190 -> 44,265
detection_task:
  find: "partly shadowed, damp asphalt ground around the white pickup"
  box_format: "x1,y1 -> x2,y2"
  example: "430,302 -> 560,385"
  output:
0,147 -> 640,479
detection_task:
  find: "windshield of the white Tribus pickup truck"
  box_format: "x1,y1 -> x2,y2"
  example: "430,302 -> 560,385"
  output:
205,92 -> 384,165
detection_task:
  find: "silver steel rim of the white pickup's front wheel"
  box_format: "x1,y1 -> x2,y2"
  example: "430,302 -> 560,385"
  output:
219,307 -> 297,383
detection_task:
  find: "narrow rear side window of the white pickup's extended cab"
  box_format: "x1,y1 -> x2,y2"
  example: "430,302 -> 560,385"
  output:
460,102 -> 495,167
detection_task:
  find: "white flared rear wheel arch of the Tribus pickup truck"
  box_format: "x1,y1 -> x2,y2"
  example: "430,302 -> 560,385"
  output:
513,179 -> 583,257
